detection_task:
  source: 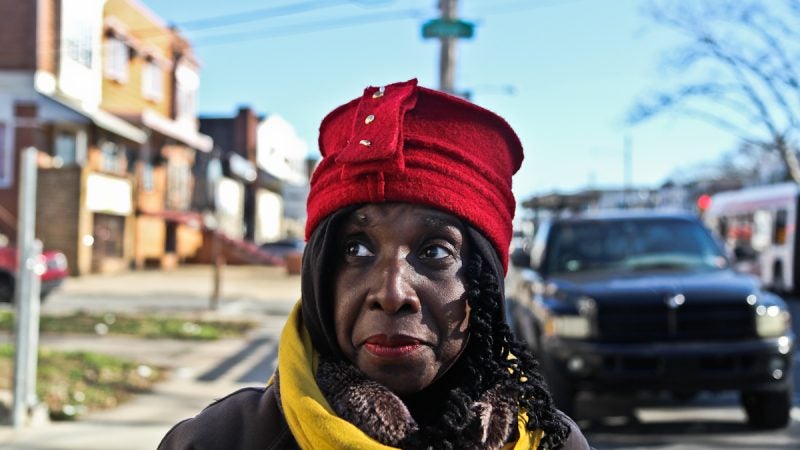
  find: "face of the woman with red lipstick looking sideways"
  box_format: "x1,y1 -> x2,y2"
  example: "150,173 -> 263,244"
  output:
334,203 -> 469,395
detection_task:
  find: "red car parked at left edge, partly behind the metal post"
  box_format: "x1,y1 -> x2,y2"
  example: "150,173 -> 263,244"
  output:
0,247 -> 69,303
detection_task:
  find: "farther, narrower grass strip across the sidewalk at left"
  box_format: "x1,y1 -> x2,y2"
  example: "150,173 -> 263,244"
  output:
0,311 -> 256,340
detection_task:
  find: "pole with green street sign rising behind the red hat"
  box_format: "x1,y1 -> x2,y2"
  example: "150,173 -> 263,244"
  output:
422,0 -> 475,94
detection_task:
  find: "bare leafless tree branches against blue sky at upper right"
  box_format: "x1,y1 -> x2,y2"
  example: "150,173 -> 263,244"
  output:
628,0 -> 800,183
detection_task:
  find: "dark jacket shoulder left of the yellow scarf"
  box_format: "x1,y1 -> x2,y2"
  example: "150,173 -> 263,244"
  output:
158,385 -> 298,450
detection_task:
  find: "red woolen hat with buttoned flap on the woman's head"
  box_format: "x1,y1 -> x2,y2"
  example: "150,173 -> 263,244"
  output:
306,79 -> 522,270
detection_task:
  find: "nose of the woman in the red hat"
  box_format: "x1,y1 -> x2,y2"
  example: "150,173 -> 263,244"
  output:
367,257 -> 420,314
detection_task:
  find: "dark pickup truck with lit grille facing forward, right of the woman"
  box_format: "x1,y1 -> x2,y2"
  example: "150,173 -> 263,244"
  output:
506,212 -> 795,428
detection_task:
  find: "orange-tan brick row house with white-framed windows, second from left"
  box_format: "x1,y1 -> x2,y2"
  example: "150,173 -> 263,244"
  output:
101,0 -> 213,267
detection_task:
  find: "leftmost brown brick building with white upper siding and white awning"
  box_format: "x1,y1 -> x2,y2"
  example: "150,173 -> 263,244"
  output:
0,0 -> 147,274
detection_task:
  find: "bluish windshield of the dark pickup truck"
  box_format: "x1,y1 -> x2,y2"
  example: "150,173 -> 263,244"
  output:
545,218 -> 727,274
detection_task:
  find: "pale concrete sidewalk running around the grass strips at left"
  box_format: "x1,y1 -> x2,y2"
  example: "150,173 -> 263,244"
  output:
0,266 -> 300,450
